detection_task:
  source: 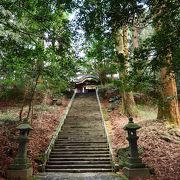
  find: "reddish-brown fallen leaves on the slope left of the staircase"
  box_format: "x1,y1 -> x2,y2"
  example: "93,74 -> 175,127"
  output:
0,99 -> 69,179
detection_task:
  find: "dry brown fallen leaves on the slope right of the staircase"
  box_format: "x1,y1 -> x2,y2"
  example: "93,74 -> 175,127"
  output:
102,100 -> 180,180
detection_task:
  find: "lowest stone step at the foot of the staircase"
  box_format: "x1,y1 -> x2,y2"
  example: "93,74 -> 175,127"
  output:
46,168 -> 112,173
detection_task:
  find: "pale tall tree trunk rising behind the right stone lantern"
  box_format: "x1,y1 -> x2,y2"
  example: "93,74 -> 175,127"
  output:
116,25 -> 136,116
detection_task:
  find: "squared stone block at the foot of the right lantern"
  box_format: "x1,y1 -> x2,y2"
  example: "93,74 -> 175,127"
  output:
123,167 -> 150,178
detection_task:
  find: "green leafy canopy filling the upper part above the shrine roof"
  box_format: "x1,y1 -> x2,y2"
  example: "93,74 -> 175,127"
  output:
0,0 -> 180,102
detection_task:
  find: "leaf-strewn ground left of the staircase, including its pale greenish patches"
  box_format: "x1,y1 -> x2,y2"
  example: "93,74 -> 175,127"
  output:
0,99 -> 69,179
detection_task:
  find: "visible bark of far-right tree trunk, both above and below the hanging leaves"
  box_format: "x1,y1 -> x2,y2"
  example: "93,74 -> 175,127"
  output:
152,0 -> 180,126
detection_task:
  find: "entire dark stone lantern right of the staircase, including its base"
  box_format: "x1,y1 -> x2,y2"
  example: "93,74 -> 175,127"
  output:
123,117 -> 150,178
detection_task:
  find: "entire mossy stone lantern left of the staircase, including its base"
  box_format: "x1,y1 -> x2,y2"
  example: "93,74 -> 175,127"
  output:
7,122 -> 33,180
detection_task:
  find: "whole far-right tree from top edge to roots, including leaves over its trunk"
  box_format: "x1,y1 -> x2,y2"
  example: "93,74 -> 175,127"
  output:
152,1 -> 180,125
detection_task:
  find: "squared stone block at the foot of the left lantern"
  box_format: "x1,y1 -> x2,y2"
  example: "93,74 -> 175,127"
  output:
7,167 -> 33,180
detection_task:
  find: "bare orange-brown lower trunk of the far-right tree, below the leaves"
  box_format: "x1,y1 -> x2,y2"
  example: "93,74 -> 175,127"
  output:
157,51 -> 180,125
